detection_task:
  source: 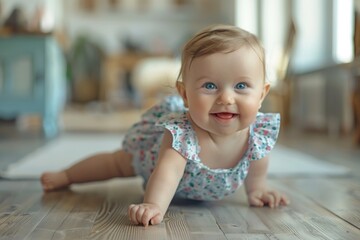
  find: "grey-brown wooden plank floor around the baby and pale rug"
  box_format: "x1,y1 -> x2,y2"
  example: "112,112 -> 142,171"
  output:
0,123 -> 360,240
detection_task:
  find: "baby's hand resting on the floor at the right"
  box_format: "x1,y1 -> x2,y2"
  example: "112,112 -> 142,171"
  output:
248,190 -> 290,208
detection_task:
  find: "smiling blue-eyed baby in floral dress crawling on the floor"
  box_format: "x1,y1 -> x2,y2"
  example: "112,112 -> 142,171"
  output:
41,25 -> 289,226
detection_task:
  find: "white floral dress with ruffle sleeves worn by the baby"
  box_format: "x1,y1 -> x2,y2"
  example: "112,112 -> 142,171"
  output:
123,96 -> 280,200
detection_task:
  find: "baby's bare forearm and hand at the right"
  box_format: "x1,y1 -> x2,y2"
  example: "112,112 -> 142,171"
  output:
245,157 -> 290,208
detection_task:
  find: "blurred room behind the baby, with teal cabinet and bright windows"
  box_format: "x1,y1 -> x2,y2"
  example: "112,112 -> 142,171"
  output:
0,0 -> 360,145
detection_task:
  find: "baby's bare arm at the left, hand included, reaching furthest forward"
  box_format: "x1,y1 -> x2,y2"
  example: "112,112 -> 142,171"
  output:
128,131 -> 186,226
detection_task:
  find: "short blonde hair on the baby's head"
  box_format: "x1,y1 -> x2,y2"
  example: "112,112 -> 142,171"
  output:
177,25 -> 265,81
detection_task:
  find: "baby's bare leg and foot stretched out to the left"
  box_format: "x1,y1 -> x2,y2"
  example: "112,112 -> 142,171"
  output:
40,150 -> 135,191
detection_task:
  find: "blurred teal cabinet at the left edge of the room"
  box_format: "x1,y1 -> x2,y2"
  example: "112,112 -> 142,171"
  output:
0,35 -> 66,137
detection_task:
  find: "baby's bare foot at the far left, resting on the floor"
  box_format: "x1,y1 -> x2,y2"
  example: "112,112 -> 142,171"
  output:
40,171 -> 70,191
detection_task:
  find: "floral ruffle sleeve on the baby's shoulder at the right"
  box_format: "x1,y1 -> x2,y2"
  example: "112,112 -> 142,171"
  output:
248,113 -> 280,160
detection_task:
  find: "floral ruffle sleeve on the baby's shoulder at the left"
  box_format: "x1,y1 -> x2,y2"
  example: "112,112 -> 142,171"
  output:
156,112 -> 200,161
